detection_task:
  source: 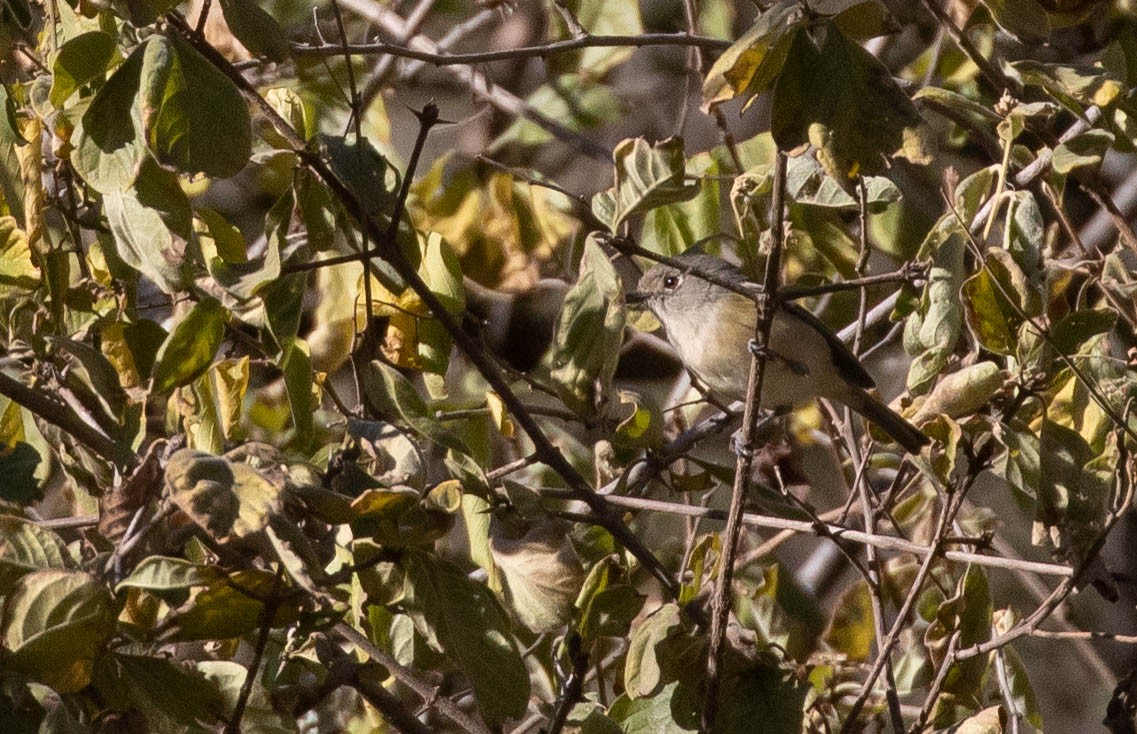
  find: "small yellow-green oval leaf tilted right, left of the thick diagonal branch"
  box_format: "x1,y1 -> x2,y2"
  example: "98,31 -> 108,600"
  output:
152,298 -> 229,394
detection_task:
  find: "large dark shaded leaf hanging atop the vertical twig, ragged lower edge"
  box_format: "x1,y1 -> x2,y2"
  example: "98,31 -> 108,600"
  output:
771,24 -> 929,181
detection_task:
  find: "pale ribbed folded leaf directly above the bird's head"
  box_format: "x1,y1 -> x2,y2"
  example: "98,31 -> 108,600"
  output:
592,137 -> 699,232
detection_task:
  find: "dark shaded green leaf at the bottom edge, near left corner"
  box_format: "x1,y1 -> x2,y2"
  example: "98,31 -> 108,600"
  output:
91,653 -> 228,732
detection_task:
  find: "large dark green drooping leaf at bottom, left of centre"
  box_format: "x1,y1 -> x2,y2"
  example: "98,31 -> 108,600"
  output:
402,551 -> 529,726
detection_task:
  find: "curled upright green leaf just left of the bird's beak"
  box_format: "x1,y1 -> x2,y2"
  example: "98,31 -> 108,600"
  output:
550,237 -> 625,417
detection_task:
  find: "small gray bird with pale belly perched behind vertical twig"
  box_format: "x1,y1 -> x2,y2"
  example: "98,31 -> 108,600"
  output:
628,252 -> 929,453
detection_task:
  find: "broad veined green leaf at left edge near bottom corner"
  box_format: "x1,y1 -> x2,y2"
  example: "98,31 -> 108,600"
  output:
2,568 -> 115,693
